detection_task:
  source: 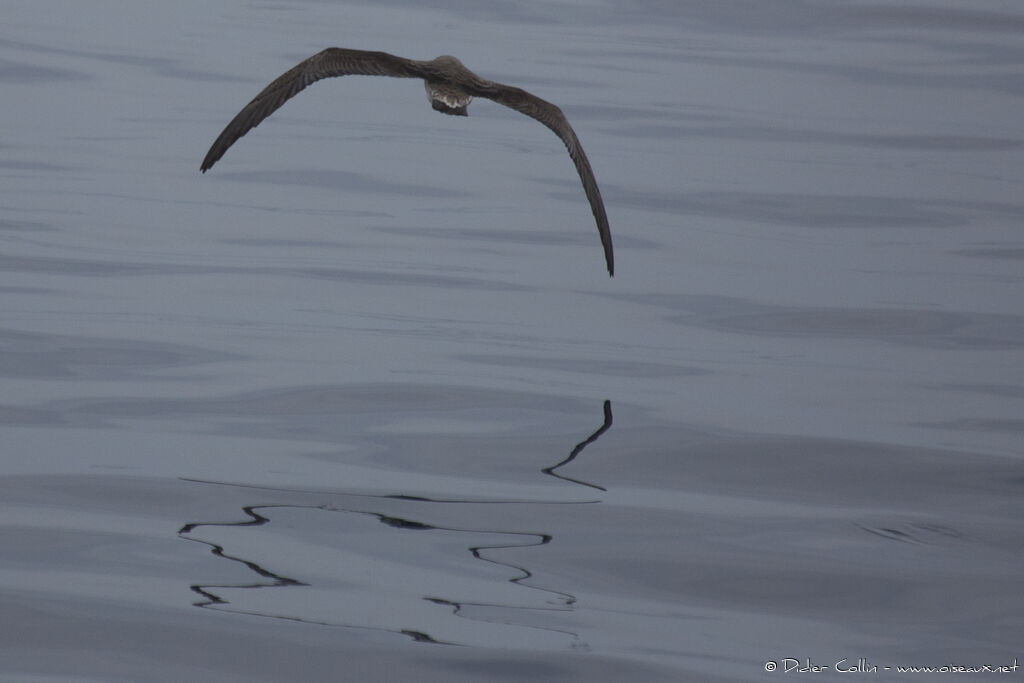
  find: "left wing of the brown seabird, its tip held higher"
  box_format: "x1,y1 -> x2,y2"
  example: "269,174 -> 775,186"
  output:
200,47 -> 423,173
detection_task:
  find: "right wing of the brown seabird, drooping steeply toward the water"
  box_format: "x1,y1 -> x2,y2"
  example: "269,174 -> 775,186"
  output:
465,82 -> 615,275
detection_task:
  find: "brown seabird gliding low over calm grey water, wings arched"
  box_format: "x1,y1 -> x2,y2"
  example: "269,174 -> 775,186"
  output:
200,47 -> 615,275
